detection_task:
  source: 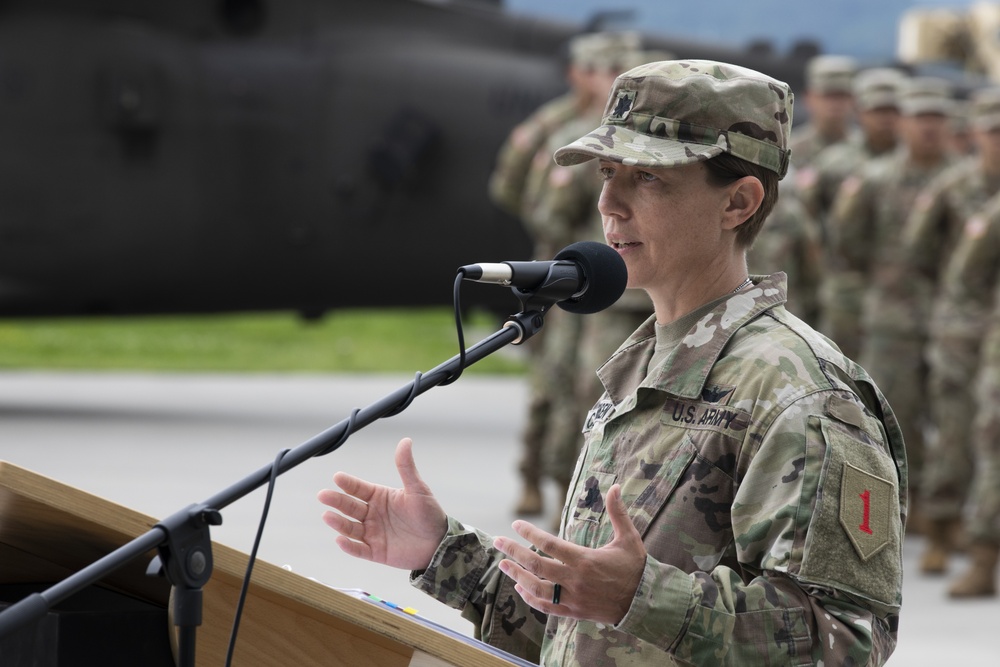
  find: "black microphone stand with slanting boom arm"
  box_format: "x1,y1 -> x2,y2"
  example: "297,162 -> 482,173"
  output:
0,310 -> 553,667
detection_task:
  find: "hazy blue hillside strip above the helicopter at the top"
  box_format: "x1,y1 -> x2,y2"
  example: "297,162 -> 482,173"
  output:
503,0 -> 970,60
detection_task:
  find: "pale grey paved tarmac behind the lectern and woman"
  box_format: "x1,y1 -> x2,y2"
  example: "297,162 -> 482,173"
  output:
0,372 -> 1000,667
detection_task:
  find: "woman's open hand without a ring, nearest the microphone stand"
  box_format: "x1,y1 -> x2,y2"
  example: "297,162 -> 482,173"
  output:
318,438 -> 448,570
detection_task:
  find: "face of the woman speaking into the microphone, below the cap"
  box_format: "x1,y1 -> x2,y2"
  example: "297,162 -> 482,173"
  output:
598,160 -> 729,294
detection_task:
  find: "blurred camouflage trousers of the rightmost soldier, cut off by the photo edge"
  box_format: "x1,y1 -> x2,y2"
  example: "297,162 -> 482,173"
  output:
966,364 -> 1000,543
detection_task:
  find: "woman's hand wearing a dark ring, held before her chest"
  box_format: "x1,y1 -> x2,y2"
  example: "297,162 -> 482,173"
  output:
493,484 -> 646,625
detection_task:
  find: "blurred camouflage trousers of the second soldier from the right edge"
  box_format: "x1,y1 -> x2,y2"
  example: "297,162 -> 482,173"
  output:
920,335 -> 979,519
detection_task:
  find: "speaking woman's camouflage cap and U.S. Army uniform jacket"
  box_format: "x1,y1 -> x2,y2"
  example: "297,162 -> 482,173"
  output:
411,61 -> 906,667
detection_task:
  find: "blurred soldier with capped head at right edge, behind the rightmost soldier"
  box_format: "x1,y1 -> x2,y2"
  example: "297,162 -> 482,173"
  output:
900,87 -> 1000,573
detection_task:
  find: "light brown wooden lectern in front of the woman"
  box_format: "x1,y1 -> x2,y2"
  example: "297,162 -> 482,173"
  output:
0,461 -> 524,667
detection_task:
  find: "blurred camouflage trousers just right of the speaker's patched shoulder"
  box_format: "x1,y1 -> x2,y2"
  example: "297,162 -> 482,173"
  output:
860,329 -> 927,492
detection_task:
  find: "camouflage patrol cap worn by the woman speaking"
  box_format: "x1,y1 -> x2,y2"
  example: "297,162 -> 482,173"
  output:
555,60 -> 793,178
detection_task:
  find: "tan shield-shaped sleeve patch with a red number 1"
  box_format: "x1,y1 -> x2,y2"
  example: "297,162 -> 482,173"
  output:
840,463 -> 895,561
